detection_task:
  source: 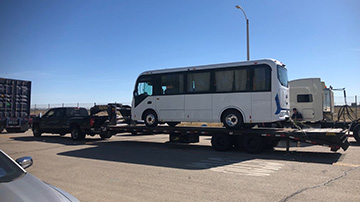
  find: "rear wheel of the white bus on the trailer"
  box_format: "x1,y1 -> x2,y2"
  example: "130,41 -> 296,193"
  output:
221,109 -> 244,129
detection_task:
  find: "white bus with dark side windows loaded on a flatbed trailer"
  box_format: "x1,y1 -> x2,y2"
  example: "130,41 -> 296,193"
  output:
131,59 -> 289,129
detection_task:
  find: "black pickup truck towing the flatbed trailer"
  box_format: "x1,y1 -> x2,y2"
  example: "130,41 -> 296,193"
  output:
32,107 -> 97,140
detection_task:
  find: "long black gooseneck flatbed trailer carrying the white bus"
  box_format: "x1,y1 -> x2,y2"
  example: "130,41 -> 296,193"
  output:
90,103 -> 350,153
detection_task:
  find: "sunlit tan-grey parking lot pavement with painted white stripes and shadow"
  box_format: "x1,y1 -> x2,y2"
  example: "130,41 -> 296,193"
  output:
0,130 -> 360,202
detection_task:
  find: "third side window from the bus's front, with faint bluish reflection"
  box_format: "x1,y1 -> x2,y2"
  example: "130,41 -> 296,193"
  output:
187,72 -> 210,93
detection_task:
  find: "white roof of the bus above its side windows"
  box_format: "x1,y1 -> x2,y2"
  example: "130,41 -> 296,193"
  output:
140,59 -> 285,75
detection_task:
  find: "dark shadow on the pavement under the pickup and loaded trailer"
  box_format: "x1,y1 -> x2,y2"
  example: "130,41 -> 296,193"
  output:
12,136 -> 342,170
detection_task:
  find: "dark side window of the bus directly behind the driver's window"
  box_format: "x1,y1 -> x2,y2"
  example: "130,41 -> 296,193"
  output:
161,74 -> 184,95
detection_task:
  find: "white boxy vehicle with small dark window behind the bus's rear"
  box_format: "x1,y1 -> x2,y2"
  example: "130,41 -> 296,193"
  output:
289,78 -> 334,122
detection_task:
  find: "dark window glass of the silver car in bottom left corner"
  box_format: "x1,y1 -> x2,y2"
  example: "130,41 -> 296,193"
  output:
0,150 -> 25,183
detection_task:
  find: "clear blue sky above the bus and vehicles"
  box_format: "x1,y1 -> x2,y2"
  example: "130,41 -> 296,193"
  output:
0,0 -> 360,104
